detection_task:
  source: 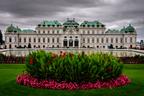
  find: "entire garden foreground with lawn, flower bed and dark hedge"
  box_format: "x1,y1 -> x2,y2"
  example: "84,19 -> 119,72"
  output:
0,50 -> 144,96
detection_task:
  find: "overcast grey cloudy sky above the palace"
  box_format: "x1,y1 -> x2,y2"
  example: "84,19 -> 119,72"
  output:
0,0 -> 144,41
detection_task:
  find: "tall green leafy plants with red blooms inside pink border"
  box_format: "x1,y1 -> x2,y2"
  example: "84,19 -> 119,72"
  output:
26,51 -> 123,83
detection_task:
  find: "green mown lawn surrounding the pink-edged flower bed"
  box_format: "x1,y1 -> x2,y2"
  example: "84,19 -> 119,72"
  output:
0,64 -> 144,96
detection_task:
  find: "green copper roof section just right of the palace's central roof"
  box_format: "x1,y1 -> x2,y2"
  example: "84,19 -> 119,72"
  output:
81,21 -> 105,27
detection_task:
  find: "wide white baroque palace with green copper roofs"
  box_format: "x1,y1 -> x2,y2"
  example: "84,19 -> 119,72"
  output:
5,19 -> 137,49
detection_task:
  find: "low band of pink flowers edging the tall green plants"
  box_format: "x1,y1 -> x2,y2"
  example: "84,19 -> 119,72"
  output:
16,74 -> 131,90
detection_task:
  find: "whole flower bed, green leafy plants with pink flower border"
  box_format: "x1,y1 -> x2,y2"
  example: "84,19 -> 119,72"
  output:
17,51 -> 130,89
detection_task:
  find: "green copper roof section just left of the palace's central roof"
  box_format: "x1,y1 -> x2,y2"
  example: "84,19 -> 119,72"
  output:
38,20 -> 61,27
